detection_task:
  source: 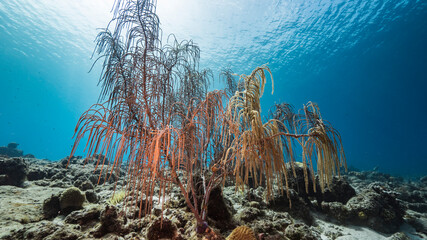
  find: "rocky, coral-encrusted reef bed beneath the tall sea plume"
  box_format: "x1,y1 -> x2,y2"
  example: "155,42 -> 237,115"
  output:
0,156 -> 427,240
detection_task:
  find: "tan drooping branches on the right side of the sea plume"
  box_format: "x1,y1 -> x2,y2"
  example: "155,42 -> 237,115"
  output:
222,66 -> 345,202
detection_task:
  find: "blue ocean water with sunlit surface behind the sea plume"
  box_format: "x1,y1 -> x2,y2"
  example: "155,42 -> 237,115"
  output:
0,0 -> 427,176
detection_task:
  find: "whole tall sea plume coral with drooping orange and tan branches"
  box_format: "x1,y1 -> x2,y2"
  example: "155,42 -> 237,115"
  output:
70,0 -> 345,237
